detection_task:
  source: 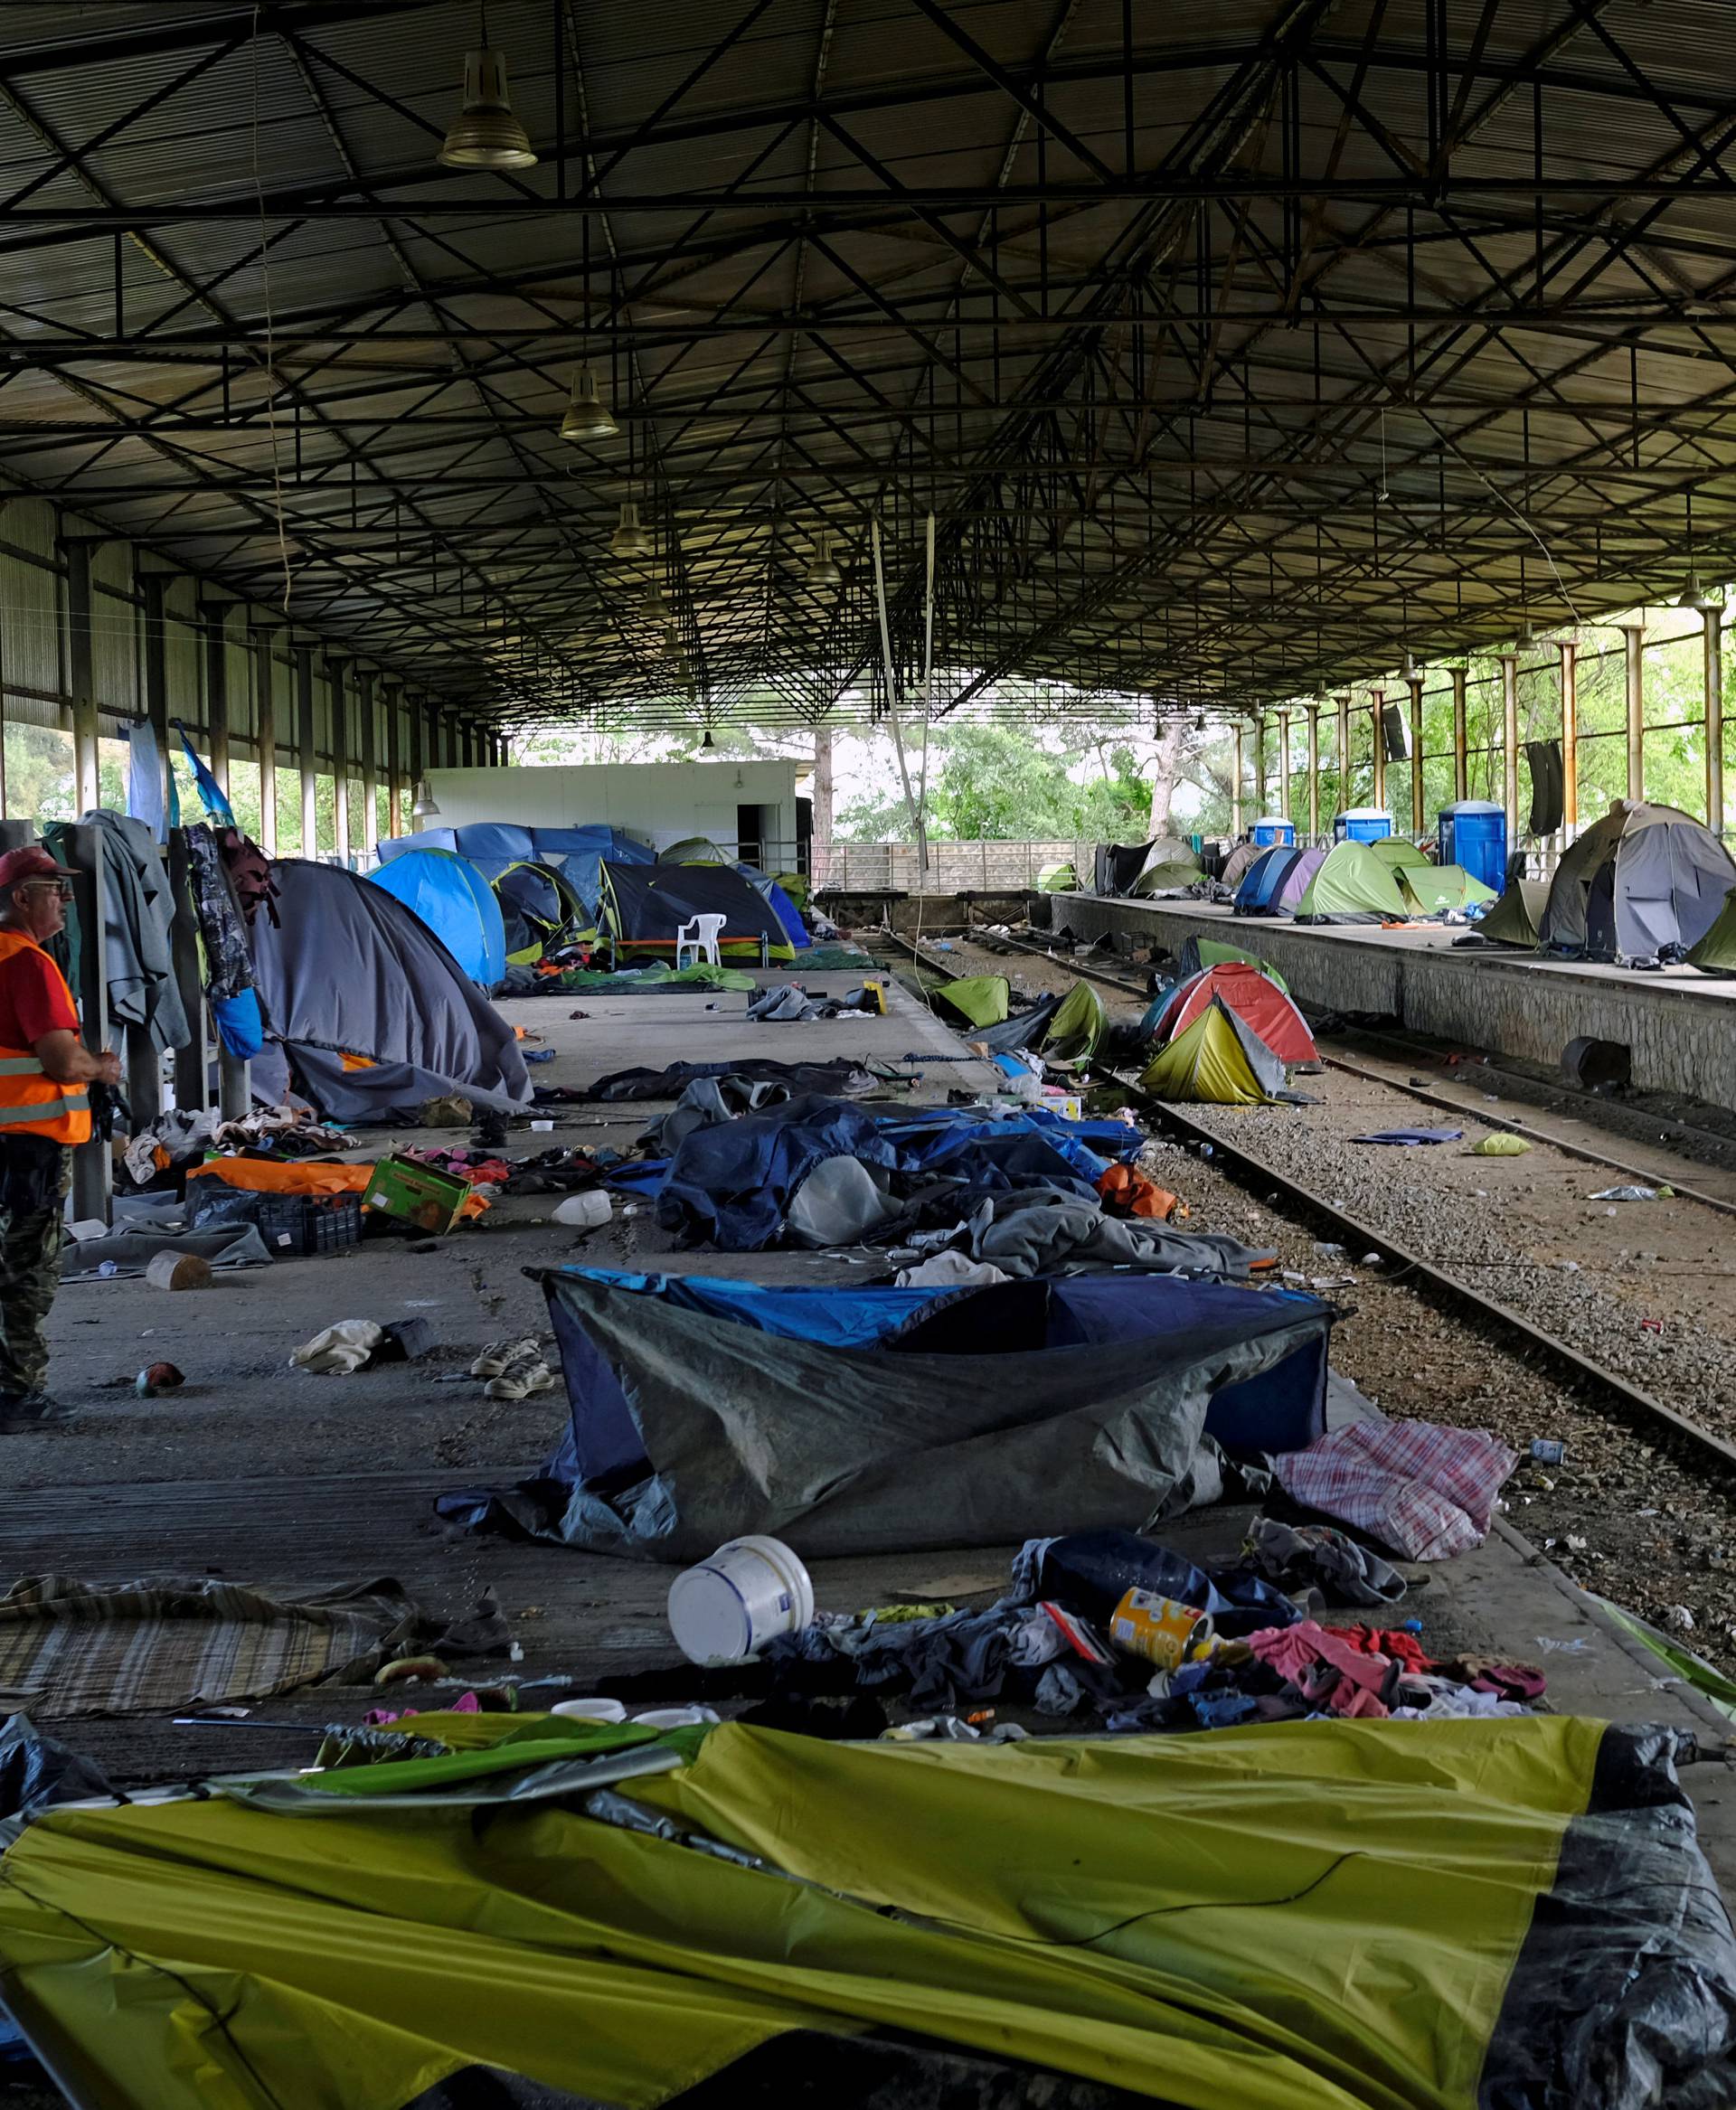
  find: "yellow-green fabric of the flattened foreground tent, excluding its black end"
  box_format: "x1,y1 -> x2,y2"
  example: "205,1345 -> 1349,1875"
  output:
0,1716 -> 1601,2110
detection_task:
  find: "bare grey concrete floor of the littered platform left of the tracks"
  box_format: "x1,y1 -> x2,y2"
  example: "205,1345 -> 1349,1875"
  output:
0,975 -> 1736,1890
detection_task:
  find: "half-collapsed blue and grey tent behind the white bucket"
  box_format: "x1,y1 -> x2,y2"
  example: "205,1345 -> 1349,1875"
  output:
441,1270 -> 1331,1561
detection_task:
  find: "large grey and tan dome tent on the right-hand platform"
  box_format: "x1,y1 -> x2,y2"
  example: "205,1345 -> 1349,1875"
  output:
1538,800 -> 1736,965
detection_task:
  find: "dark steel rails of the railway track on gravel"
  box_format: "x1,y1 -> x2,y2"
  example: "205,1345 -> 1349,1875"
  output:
869,933 -> 1736,1477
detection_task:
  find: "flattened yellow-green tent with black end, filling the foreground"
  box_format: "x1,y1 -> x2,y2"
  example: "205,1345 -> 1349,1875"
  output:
0,1713 -> 1736,2110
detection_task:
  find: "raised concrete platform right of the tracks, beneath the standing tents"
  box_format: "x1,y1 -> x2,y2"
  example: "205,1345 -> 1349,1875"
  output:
1046,895 -> 1736,1110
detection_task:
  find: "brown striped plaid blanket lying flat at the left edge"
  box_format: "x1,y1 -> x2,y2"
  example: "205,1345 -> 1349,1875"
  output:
0,1576 -> 420,1719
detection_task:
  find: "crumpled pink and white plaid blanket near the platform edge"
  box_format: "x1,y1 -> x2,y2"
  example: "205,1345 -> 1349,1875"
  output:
1272,1420 -> 1519,1561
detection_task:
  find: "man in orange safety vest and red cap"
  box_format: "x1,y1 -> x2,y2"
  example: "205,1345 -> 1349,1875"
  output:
0,848 -> 120,1435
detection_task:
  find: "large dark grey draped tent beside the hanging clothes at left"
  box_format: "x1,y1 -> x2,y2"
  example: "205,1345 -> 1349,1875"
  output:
251,857 -> 532,1123
